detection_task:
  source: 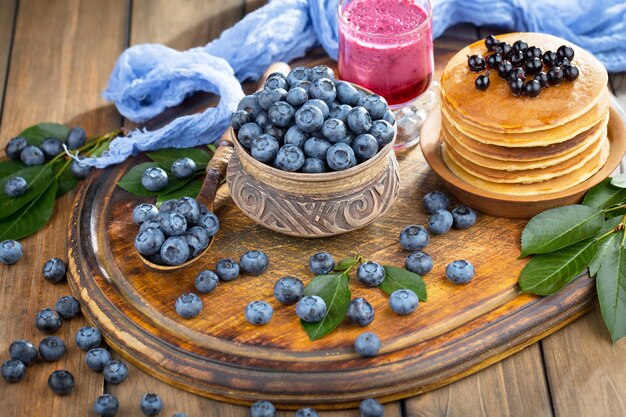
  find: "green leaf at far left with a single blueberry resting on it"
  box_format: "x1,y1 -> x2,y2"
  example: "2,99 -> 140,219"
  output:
0,165 -> 55,219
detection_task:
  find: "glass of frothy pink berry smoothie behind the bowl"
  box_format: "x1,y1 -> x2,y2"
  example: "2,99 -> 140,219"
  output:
338,0 -> 436,149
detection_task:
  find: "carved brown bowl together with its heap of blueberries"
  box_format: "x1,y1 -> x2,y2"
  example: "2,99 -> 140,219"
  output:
226,65 -> 400,238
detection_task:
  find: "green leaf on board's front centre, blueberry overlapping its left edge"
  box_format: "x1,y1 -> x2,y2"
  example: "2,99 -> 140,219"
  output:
300,274 -> 352,341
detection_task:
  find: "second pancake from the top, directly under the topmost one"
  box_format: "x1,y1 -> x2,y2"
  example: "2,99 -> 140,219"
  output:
441,88 -> 610,147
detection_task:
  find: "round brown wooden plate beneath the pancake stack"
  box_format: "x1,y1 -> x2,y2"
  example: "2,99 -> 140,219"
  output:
420,106 -> 626,219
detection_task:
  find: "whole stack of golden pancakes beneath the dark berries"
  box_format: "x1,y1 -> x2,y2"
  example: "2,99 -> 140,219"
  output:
441,33 -> 610,196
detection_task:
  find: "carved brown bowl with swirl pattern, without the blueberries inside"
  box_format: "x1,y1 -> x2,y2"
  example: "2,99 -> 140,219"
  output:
226,118 -> 400,238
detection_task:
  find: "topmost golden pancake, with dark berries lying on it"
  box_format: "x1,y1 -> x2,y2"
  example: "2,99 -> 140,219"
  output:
441,33 -> 608,134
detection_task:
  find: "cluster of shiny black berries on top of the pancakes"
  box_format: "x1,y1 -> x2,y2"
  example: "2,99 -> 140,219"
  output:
467,35 -> 578,98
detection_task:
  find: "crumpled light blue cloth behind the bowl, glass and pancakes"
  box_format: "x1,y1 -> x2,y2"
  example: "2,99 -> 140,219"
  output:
82,0 -> 626,168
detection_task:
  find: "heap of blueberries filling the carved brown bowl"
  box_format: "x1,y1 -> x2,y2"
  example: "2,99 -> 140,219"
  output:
231,65 -> 395,174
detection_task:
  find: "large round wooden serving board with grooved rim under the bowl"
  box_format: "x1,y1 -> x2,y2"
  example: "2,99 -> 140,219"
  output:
69,139 -> 595,408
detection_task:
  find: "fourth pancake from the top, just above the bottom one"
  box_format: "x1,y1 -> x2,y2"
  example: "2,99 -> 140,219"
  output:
438,127 -> 606,184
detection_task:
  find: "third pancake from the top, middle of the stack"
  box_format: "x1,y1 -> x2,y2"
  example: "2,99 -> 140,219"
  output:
442,114 -> 608,167
